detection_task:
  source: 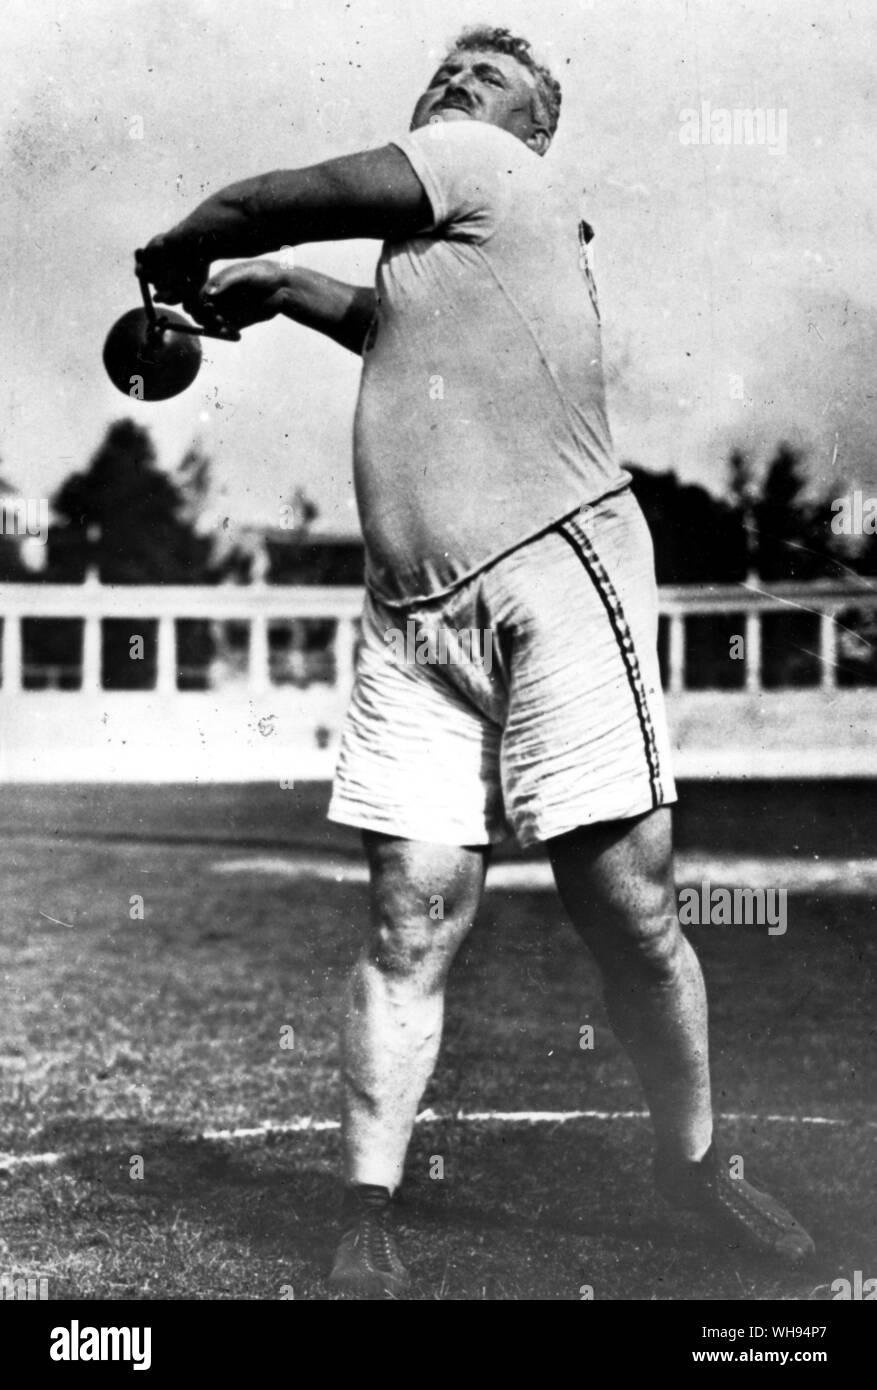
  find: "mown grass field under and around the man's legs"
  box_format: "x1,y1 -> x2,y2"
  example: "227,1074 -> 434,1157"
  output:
0,785 -> 877,1300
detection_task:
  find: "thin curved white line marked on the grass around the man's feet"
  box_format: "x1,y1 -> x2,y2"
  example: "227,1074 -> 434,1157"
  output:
0,1111 -> 877,1173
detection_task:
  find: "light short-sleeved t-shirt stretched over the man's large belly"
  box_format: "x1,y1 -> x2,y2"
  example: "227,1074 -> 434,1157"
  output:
353,121 -> 630,603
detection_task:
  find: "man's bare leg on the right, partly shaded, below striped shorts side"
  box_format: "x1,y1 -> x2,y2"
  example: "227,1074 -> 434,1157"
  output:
548,808 -> 713,1162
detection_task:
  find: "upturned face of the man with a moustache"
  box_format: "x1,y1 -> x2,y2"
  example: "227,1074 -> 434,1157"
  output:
411,51 -> 550,154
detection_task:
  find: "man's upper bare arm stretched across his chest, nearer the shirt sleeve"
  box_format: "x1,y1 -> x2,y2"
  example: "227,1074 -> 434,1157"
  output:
143,145 -> 432,303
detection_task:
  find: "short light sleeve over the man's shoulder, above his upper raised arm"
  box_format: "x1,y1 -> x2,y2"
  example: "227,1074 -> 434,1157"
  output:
391,121 -> 528,242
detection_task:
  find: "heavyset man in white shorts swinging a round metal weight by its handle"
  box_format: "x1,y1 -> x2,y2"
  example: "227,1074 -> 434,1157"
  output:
146,29 -> 813,1297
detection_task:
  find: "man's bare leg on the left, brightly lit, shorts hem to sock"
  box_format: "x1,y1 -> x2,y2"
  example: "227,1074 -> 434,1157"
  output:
342,831 -> 486,1193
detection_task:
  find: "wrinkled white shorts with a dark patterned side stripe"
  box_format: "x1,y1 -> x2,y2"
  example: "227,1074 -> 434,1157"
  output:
329,491 -> 675,845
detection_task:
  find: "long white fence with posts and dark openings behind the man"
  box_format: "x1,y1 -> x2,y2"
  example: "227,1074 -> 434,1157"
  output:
0,569 -> 877,783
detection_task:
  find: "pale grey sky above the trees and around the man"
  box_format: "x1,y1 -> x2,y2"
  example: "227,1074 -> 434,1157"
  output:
0,0 -> 877,532
